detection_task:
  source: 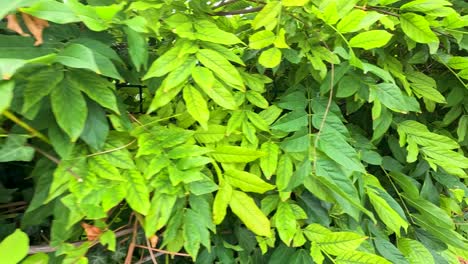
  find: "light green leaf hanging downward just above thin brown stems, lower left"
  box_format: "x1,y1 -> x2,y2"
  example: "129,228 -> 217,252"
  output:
122,170 -> 151,215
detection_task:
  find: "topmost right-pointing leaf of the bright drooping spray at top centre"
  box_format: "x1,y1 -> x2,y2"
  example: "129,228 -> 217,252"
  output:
194,19 -> 242,45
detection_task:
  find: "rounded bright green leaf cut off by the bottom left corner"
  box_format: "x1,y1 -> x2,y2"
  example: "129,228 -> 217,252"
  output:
0,229 -> 29,264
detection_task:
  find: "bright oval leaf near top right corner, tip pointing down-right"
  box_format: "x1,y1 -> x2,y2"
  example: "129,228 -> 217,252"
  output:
400,13 -> 439,43
